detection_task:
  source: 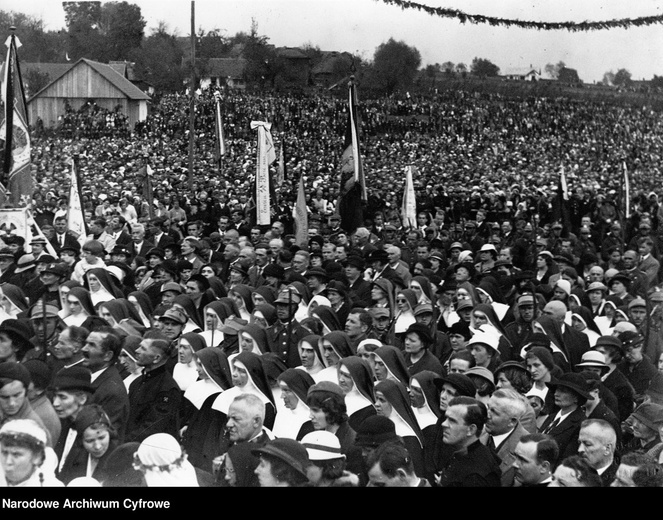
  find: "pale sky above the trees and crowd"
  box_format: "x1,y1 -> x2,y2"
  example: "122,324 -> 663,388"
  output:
0,0 -> 663,83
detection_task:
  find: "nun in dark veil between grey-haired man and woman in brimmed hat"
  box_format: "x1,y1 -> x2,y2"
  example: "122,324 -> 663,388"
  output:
272,368 -> 315,440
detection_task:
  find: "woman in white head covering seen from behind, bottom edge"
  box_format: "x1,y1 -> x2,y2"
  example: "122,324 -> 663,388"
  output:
134,433 -> 200,487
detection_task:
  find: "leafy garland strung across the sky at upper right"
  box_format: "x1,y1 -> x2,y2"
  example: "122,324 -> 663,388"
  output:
382,0 -> 663,32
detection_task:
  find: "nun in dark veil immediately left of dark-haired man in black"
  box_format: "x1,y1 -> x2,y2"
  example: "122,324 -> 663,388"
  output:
410,370 -> 442,484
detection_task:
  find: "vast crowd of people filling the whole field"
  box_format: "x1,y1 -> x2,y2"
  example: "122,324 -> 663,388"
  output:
0,85 -> 663,487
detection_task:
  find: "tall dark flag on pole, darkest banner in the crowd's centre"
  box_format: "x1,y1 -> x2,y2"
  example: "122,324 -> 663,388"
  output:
338,76 -> 368,233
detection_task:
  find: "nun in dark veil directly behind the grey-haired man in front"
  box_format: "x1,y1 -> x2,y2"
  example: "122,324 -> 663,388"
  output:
212,352 -> 276,430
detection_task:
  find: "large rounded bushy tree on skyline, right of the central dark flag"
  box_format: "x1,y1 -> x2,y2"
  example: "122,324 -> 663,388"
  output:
372,38 -> 421,95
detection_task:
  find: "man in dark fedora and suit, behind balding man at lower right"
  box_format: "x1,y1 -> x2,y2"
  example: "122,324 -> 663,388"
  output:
540,372 -> 590,460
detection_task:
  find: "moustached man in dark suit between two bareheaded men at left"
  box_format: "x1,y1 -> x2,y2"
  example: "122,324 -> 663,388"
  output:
81,327 -> 129,443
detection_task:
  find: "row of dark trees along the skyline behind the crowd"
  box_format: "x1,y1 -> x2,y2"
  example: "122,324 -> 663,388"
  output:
0,1 -> 644,95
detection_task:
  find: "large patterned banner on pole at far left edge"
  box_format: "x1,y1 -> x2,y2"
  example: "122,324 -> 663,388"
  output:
0,27 -> 34,208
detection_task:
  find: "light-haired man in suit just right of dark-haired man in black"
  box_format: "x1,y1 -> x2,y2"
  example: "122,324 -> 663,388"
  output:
480,388 -> 528,487
